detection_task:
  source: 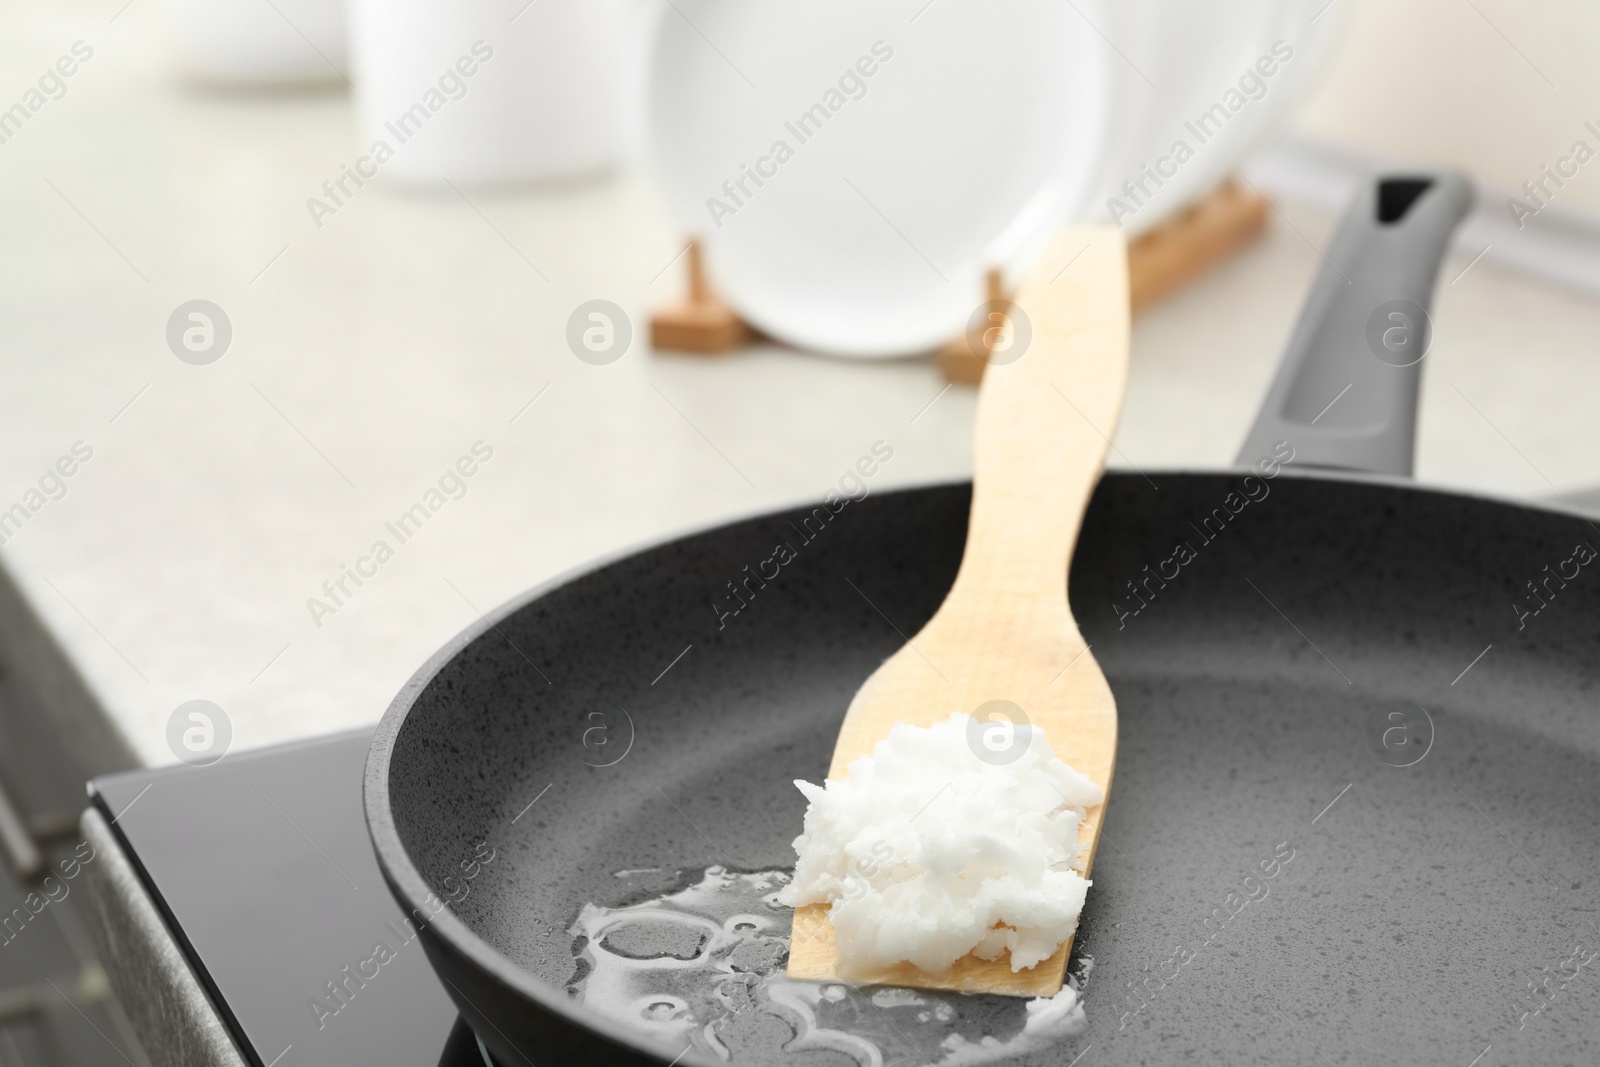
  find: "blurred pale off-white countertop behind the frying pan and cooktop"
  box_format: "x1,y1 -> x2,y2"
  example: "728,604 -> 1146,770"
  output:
9,3 -> 1600,763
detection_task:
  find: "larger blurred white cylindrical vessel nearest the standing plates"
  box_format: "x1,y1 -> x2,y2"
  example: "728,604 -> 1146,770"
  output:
350,0 -> 658,186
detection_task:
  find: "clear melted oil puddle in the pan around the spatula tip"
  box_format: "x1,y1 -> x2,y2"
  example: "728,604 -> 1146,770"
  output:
568,867 -> 1093,1067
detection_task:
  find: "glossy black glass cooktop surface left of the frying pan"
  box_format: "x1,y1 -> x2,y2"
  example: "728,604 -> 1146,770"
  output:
93,731 -> 485,1067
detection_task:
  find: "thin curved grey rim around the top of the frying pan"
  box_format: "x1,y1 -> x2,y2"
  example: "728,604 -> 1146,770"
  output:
362,467 -> 1597,1064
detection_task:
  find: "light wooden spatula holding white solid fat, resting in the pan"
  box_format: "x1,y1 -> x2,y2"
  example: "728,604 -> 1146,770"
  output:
789,227 -> 1128,997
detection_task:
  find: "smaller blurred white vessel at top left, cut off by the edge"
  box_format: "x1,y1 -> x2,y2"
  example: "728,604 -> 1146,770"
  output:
162,0 -> 347,86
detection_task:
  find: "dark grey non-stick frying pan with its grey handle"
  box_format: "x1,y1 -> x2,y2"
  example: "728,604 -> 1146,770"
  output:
365,174 -> 1600,1067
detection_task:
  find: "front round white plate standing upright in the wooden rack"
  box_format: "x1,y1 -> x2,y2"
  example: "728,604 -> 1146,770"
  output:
651,0 -> 1110,357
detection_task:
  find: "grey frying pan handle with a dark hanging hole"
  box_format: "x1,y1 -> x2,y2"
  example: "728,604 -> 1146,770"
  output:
1237,171 -> 1472,477
